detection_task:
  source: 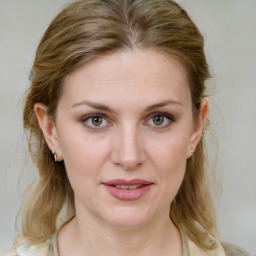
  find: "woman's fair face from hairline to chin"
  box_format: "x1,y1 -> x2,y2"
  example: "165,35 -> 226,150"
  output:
35,50 -> 206,228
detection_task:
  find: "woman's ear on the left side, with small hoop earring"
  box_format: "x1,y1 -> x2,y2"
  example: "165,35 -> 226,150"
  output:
34,103 -> 63,161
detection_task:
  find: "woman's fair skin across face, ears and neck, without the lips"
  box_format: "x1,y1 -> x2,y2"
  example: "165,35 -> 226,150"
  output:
34,49 -> 208,256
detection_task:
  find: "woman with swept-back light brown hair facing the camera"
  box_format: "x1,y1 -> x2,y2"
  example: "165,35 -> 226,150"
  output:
6,0 -> 250,256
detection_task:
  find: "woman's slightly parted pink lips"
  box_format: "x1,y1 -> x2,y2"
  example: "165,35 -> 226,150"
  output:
103,179 -> 153,201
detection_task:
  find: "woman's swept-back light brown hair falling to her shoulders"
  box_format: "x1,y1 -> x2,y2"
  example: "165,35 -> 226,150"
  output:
22,0 -> 217,249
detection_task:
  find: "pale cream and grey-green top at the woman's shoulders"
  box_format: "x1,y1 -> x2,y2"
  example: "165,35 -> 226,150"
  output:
6,234 -> 250,256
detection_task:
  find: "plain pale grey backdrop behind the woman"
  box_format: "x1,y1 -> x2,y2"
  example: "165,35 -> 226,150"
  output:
0,0 -> 256,252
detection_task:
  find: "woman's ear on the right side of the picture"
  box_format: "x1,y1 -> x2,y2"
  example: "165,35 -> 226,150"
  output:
188,97 -> 209,158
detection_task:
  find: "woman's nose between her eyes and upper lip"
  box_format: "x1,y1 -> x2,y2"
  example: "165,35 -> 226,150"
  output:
111,125 -> 146,170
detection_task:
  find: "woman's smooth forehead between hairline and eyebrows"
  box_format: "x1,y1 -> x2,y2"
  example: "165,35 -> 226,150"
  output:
63,49 -> 190,108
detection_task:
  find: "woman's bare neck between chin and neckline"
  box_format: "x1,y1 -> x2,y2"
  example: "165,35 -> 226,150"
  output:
58,207 -> 182,256
